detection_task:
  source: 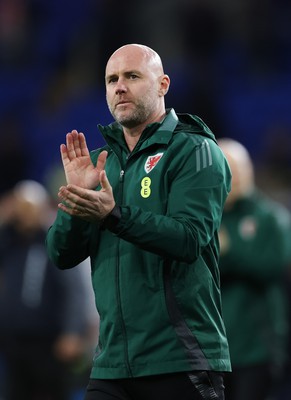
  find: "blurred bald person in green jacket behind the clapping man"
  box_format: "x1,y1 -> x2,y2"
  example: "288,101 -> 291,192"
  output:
218,138 -> 291,400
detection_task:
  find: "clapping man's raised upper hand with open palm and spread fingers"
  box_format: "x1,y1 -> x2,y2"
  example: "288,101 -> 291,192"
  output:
60,130 -> 107,189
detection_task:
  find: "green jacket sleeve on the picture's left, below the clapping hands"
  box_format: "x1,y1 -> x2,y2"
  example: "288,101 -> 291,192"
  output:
46,210 -> 92,269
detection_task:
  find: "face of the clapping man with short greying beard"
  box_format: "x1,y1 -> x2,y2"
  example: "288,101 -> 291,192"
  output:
105,49 -> 161,128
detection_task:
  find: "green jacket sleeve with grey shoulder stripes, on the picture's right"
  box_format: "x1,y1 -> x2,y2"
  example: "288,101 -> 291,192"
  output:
106,141 -> 230,263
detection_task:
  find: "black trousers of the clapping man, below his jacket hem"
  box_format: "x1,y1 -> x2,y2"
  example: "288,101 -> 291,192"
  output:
85,371 -> 224,400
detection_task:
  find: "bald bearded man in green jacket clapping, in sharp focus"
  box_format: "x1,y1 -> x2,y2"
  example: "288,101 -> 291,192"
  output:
47,44 -> 230,400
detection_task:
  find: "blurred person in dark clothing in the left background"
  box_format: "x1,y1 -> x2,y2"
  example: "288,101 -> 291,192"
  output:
0,180 -> 98,400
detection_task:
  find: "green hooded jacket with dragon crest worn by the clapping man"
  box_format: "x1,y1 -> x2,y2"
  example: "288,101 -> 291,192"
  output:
47,109 -> 230,379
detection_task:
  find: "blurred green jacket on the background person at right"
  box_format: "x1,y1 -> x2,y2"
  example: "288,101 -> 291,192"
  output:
220,191 -> 291,368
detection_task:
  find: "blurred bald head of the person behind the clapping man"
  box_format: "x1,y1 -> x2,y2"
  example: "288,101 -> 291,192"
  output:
218,138 -> 255,205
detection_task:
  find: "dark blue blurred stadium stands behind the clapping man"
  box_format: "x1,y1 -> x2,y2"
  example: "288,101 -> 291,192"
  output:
0,0 -> 291,400
